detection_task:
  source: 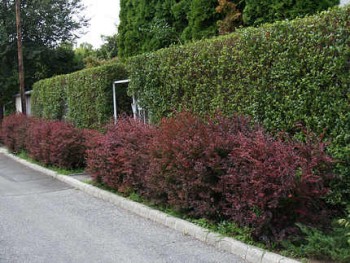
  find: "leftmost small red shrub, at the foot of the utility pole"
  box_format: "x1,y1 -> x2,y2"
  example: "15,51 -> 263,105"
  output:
1,113 -> 30,153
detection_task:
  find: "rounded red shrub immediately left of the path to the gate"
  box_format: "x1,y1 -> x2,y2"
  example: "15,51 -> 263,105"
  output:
27,120 -> 86,169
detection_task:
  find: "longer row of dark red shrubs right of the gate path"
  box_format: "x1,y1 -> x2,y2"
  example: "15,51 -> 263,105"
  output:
87,113 -> 332,241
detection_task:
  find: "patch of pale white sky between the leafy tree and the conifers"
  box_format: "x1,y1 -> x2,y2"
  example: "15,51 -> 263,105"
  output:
77,0 -> 120,48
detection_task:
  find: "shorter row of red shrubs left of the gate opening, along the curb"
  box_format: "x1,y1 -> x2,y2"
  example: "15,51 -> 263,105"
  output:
1,114 -> 87,169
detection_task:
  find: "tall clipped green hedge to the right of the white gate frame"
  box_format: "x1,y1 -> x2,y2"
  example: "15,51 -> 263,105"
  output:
128,6 -> 350,203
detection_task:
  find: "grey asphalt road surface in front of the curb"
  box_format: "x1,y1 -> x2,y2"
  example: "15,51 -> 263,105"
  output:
0,154 -> 244,263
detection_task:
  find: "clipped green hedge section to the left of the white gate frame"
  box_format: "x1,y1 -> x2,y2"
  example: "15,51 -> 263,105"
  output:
32,63 -> 127,128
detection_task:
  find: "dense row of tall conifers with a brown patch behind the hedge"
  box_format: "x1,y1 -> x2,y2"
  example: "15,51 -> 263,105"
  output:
118,0 -> 339,57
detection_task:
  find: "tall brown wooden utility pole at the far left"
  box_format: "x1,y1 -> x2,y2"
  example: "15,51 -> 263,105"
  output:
16,0 -> 27,115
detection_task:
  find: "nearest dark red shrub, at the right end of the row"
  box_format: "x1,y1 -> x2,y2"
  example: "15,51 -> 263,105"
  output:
221,129 -> 332,240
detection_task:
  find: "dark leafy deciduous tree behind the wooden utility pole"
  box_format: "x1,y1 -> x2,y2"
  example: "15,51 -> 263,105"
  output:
0,0 -> 88,118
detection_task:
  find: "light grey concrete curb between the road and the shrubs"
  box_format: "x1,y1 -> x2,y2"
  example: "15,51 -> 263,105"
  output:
0,147 -> 300,263
